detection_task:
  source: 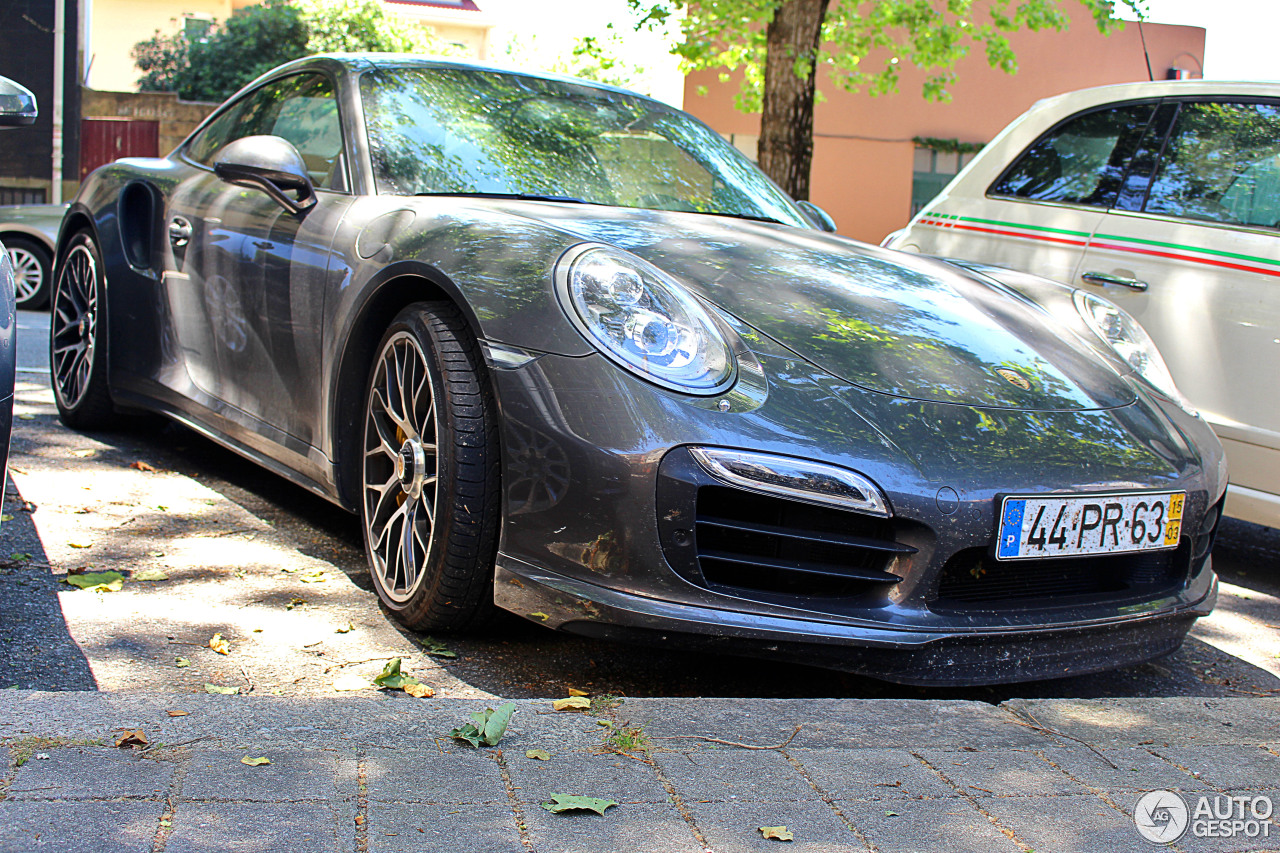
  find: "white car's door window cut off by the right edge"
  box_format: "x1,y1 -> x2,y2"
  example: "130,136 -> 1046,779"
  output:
1146,104 -> 1280,228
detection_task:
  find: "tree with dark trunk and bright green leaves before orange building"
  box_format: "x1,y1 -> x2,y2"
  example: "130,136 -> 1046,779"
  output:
628,0 -> 1143,197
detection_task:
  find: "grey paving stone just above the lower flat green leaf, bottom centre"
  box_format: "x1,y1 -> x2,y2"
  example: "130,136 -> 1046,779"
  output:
506,752 -> 671,804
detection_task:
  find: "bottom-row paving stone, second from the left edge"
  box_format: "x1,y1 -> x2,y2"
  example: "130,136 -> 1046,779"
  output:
164,802 -> 356,853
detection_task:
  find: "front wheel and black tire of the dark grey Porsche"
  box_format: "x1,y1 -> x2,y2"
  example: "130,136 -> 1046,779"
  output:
360,302 -> 502,630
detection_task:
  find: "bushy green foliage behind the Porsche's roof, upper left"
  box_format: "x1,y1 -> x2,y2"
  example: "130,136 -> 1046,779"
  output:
132,0 -> 452,101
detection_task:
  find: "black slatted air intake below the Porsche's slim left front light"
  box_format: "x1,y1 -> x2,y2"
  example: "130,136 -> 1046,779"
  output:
694,485 -> 915,597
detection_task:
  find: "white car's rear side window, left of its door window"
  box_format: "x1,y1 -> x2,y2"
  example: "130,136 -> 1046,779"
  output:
989,104 -> 1156,207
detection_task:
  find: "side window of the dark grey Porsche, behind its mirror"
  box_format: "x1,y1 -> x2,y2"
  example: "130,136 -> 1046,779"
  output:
187,74 -> 347,191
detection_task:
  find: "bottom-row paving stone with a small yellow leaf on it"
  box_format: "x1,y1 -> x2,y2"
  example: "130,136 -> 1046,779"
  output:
687,798 -> 869,853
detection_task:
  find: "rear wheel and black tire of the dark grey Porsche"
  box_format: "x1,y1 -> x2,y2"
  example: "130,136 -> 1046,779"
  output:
49,232 -> 116,429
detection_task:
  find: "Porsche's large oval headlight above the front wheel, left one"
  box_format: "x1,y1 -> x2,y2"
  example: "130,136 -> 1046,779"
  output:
556,245 -> 736,396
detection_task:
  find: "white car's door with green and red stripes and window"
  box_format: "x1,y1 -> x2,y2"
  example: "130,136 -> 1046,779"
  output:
1074,99 -> 1280,512
